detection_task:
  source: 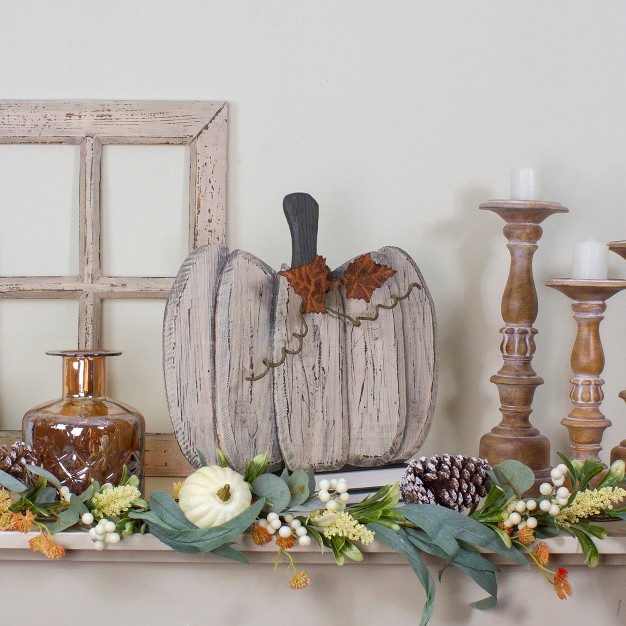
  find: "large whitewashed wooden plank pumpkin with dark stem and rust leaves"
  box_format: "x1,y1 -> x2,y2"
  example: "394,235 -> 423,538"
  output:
163,194 -> 437,470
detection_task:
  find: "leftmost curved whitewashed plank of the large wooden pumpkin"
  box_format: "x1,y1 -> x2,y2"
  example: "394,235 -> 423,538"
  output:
163,245 -> 228,466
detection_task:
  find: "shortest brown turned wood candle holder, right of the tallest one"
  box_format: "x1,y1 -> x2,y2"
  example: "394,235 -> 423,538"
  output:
546,278 -> 626,461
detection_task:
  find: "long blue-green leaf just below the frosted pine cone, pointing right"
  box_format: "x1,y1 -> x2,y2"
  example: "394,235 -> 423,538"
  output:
398,504 -> 530,568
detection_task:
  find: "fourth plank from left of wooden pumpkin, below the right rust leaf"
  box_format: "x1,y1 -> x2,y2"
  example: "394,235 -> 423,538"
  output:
336,252 -> 406,467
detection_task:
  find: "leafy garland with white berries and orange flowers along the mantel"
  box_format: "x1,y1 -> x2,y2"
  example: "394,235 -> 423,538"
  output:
0,453 -> 626,624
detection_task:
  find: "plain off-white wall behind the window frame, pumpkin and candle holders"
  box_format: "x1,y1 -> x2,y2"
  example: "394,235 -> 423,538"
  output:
0,0 -> 626,468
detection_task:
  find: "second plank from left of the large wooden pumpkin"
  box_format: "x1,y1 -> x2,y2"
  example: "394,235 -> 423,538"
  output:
215,250 -> 282,471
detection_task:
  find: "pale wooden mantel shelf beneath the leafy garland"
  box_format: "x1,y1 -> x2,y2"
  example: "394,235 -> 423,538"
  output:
0,522 -> 626,567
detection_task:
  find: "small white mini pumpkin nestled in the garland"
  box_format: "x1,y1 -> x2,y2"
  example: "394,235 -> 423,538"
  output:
178,465 -> 252,528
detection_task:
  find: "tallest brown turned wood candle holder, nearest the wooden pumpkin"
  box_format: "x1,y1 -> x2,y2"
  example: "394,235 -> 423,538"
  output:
480,200 -> 568,487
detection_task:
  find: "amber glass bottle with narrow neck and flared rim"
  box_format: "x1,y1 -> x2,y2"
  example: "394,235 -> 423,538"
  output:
22,350 -> 145,493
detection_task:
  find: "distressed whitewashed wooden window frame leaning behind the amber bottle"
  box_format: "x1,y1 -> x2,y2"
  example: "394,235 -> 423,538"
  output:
0,100 -> 227,349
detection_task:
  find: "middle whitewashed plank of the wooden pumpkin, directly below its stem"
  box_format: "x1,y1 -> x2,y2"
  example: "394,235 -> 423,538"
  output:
273,276 -> 348,470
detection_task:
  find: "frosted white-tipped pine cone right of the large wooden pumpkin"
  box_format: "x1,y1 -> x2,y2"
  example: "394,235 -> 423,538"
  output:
400,454 -> 491,511
